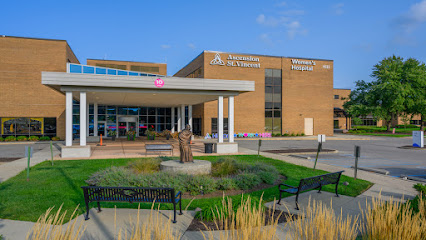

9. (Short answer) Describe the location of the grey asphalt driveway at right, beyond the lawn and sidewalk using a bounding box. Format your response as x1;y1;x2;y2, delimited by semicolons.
238;135;426;179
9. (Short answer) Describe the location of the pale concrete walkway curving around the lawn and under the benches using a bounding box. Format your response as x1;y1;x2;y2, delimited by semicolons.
0;144;416;240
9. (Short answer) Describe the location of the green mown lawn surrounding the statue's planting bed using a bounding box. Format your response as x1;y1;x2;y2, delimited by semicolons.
0;155;372;221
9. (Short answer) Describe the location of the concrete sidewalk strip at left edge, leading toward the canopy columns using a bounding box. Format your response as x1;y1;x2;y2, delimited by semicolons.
0;144;62;183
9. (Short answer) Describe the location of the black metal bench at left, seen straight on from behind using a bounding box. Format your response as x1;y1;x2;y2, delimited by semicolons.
81;186;182;223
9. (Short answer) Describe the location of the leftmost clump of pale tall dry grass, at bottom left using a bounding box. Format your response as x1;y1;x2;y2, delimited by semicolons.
26;205;86;240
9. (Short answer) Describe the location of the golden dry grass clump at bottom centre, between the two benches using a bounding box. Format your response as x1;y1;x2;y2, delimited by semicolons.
202;196;279;240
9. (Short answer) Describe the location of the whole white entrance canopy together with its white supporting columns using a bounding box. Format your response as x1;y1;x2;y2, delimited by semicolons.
42;63;255;154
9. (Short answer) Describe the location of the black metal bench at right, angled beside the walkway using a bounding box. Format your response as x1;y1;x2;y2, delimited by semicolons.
277;171;344;210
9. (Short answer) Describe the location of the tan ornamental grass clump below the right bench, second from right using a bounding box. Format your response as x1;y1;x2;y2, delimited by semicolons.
286;200;358;240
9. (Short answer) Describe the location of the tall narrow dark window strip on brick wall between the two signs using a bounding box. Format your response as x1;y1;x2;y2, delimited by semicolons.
265;69;282;134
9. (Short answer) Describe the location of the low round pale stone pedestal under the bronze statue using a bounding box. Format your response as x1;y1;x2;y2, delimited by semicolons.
160;160;212;175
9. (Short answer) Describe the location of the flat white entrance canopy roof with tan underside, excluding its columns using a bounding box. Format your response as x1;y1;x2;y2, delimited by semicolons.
42;67;254;107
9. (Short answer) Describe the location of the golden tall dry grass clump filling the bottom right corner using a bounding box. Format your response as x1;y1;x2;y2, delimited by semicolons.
361;195;426;240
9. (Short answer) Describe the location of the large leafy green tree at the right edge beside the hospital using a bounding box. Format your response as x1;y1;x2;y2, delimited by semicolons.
343;56;426;131
